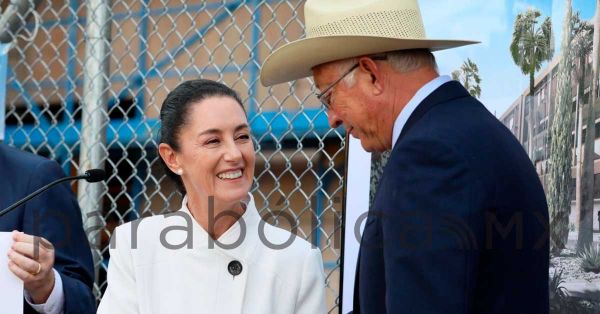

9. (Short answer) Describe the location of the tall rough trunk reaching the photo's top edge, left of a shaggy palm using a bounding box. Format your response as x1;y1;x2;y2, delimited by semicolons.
547;0;573;254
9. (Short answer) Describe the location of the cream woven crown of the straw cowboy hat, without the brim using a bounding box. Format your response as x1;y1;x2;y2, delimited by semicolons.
304;0;426;39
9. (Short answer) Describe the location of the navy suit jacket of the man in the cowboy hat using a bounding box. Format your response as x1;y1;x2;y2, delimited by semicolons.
354;81;549;314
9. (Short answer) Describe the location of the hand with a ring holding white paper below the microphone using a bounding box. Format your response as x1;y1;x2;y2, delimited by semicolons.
8;231;54;304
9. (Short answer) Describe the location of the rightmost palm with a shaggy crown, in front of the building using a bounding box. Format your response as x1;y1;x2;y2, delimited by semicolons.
571;12;596;251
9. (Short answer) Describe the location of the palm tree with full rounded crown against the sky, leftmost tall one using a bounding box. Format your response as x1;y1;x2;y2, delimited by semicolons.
510;8;554;157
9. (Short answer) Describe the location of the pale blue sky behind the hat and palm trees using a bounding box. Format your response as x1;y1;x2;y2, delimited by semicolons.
419;0;596;117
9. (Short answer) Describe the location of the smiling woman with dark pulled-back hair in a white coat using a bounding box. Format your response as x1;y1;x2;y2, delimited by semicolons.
98;80;325;314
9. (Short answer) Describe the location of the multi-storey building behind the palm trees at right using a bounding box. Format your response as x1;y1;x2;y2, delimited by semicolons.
500;39;600;240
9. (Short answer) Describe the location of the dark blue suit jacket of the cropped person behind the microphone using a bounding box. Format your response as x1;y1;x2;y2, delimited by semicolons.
0;144;96;313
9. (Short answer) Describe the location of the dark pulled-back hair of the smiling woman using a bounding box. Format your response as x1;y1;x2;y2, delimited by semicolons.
159;79;246;194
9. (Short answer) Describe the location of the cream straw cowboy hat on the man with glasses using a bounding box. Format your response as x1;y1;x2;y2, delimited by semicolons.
260;0;477;86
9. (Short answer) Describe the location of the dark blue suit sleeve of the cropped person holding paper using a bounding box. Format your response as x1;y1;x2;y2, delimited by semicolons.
23;160;96;313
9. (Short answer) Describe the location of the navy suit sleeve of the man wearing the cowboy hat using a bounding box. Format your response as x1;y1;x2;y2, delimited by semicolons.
381;137;483;314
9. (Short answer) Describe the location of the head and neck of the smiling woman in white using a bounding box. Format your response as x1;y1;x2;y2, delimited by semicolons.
159;80;256;238
